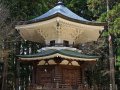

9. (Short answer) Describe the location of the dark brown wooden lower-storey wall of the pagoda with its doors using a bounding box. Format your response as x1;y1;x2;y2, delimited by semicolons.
36;65;82;89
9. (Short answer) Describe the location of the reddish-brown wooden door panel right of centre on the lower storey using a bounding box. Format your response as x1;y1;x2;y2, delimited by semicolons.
63;67;81;87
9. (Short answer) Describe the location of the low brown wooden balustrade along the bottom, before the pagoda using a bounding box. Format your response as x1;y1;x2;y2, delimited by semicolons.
27;84;109;90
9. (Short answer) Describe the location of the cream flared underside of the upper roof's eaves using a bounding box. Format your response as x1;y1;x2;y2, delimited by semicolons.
16;17;104;44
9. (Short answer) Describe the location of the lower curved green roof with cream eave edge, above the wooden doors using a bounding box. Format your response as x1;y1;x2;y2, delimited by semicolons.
18;48;99;61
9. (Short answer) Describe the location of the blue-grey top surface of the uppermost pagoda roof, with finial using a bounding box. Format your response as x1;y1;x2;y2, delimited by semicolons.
29;2;89;22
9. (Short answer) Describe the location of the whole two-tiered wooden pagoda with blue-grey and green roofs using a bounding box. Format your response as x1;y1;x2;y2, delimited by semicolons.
15;2;104;90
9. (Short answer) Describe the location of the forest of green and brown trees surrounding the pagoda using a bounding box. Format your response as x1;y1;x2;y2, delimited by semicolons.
0;0;120;90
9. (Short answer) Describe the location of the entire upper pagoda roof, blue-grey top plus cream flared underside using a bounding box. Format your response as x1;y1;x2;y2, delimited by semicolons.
15;2;105;45
